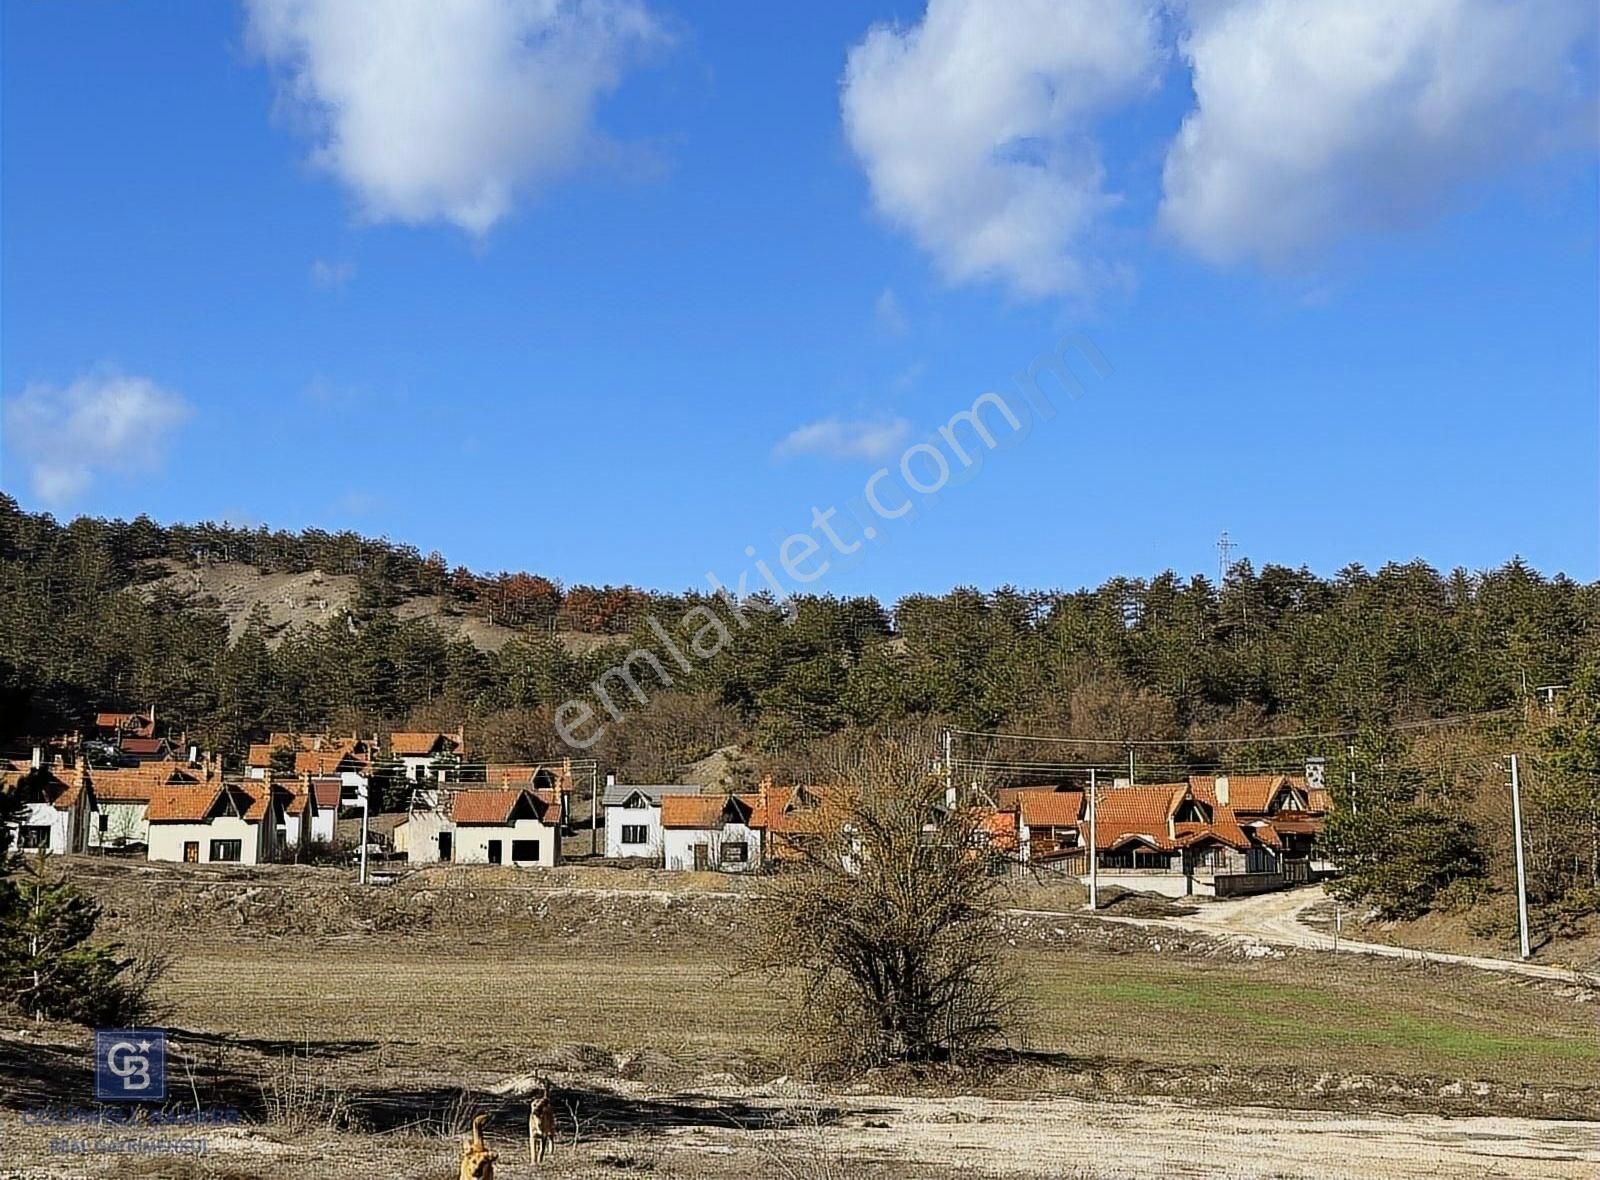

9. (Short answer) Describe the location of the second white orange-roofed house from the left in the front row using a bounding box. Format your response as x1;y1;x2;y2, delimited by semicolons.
147;780;290;865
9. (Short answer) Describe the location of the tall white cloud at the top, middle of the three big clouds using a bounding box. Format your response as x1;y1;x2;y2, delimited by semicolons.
840;0;1162;296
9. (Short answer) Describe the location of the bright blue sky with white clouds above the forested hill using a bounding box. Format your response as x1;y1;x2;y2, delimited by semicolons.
0;0;1600;598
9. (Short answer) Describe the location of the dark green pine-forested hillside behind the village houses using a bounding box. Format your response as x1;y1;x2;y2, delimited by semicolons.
0;497;1600;757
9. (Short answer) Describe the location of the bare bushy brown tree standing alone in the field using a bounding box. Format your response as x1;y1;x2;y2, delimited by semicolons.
752;734;1018;1065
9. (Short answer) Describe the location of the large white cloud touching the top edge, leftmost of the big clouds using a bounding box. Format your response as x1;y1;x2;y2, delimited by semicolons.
246;0;662;235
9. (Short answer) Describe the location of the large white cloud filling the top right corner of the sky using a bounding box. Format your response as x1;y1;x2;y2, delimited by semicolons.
1160;0;1595;264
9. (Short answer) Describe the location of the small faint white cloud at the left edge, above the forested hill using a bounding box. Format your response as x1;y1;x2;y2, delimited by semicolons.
5;374;190;505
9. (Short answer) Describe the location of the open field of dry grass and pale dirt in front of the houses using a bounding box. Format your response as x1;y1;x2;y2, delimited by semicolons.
0;868;1600;1180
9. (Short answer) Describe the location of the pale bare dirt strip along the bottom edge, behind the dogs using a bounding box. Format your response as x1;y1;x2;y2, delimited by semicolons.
0;1089;1600;1180
